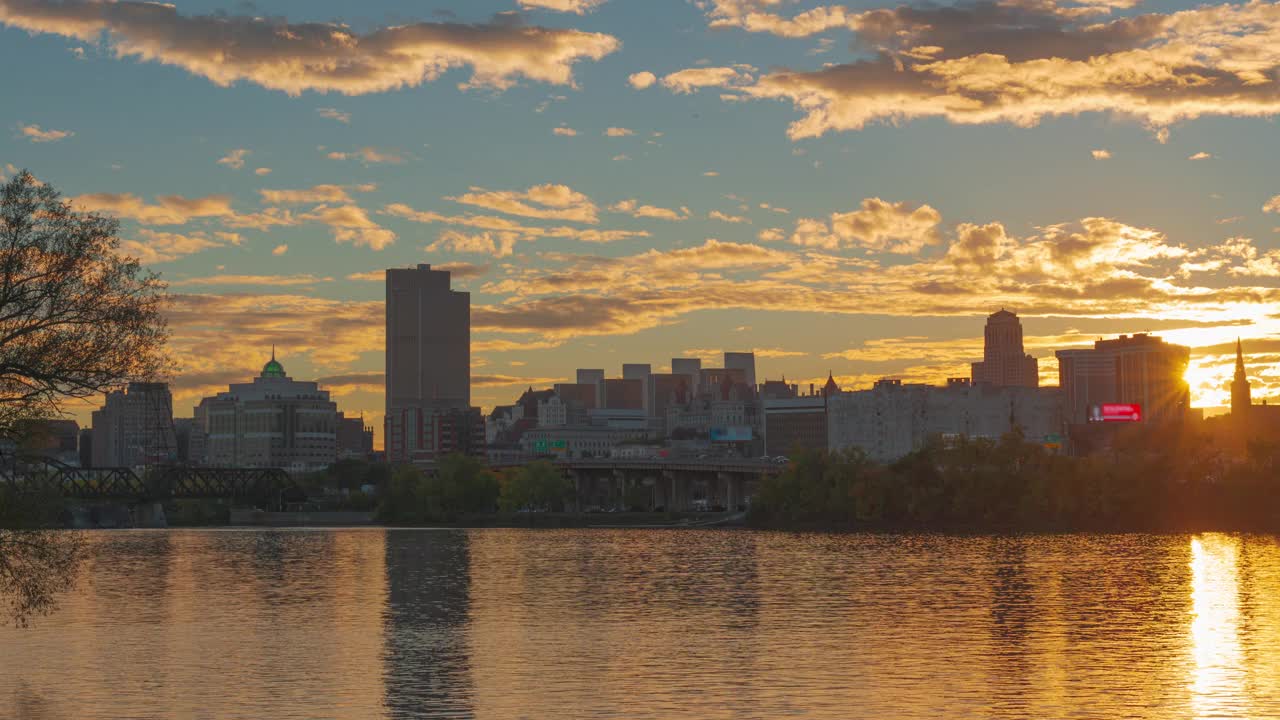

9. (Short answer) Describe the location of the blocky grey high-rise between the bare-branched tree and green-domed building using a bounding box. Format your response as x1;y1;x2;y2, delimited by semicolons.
92;383;178;468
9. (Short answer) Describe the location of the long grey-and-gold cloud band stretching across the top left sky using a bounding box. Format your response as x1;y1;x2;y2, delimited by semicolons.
0;0;620;95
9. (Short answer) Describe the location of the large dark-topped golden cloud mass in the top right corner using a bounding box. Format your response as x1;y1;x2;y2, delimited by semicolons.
713;0;1280;141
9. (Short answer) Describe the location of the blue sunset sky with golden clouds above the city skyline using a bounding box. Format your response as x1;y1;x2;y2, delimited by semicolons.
0;0;1280;436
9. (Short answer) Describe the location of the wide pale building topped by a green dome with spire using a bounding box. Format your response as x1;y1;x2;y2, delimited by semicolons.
192;347;338;473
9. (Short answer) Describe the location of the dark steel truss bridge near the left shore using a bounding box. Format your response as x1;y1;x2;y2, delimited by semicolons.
0;456;306;509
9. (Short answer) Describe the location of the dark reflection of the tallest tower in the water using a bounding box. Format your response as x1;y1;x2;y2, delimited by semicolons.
381;530;474;717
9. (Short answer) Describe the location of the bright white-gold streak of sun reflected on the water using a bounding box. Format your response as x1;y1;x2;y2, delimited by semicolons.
1190;533;1249;717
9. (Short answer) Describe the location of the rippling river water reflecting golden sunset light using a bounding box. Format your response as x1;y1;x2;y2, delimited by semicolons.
0;529;1280;719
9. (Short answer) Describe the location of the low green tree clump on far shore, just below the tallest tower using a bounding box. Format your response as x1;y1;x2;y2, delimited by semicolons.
378;455;573;524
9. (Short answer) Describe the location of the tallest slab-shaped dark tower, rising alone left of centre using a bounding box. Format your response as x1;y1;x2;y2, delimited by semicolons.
384;264;471;462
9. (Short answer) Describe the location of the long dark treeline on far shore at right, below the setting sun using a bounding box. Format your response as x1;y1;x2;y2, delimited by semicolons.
749;427;1280;532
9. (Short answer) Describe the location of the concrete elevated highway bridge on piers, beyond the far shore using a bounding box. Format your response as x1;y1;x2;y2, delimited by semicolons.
489;457;786;512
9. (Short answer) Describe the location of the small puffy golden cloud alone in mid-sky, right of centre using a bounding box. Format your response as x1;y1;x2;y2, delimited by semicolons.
791;197;942;254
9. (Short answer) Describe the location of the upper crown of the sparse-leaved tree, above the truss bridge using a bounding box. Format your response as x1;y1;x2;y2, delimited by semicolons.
0;170;169;434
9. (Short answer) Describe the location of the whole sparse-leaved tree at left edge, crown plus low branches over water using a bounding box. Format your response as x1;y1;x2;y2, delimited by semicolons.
0;170;168;624
